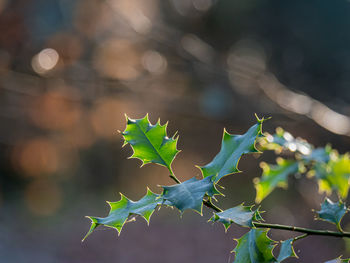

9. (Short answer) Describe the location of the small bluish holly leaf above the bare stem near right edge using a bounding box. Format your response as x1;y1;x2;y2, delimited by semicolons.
316;198;347;227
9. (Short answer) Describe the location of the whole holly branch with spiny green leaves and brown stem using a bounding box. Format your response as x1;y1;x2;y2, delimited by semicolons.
84;115;350;263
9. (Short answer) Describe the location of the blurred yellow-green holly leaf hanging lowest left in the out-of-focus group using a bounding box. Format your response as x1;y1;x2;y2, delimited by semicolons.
254;158;299;203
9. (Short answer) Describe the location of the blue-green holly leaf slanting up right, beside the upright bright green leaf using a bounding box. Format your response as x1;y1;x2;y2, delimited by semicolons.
199;118;264;182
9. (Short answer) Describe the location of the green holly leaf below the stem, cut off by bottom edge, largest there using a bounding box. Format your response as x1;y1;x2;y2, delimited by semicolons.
233;228;276;263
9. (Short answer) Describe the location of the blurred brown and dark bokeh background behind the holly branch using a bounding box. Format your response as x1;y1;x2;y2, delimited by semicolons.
0;0;350;263
